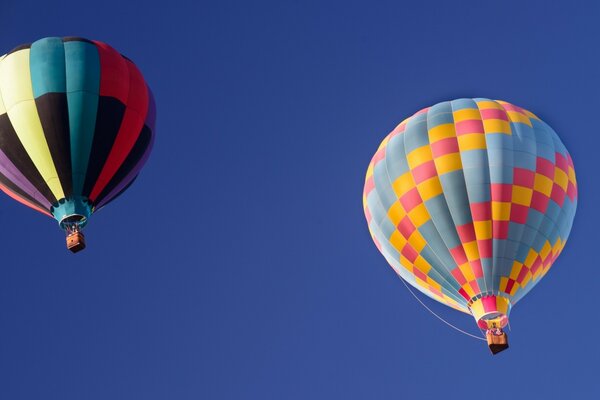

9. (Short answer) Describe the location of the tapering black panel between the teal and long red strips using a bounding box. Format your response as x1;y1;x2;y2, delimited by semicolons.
82;96;125;197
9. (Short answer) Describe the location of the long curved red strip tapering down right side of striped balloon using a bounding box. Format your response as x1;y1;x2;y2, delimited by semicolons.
90;61;149;201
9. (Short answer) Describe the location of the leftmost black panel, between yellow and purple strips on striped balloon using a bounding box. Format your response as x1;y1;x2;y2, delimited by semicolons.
0;114;58;203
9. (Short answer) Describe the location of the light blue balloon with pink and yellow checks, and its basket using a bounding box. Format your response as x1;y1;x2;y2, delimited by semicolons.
363;98;577;354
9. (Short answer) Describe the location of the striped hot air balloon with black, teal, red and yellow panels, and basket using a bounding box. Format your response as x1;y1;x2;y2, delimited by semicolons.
0;37;155;252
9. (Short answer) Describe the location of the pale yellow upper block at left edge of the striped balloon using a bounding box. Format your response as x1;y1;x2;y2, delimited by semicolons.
0;49;33;110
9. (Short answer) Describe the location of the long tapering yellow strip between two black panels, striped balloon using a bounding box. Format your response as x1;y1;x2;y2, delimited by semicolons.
2;101;65;199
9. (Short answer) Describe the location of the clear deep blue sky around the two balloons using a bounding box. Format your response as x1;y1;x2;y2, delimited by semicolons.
0;0;600;400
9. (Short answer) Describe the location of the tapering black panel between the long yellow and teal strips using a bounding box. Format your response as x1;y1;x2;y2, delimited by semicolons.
35;93;73;197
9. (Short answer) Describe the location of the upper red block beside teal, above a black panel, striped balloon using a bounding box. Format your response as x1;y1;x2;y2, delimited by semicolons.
94;42;129;104
